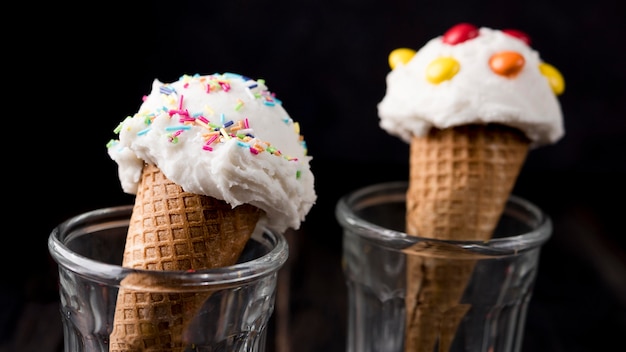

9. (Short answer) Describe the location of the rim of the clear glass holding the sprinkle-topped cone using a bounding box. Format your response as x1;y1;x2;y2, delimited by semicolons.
48;205;289;287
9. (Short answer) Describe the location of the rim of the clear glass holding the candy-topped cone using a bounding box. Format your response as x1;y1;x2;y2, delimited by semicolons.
335;181;552;256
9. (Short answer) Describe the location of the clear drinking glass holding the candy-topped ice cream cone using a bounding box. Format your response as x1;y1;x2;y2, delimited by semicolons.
336;182;552;352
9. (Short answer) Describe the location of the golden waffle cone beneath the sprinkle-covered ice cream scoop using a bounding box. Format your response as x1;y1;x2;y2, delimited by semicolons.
109;165;261;352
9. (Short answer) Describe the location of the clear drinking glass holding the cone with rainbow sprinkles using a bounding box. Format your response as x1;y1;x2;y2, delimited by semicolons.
48;206;289;352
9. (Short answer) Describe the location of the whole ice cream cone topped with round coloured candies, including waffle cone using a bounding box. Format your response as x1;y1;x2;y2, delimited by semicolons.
378;23;564;351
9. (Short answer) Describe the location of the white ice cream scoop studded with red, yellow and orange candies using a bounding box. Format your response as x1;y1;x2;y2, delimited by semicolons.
378;23;564;147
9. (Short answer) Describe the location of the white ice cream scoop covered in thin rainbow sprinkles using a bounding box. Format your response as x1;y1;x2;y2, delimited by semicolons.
107;73;316;232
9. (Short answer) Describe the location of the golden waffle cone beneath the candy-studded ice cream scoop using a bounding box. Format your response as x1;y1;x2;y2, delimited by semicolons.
405;124;529;352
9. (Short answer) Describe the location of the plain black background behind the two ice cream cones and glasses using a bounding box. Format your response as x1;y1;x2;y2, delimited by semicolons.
0;0;626;352
